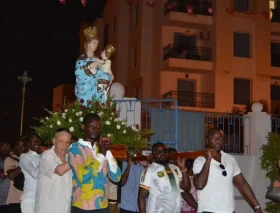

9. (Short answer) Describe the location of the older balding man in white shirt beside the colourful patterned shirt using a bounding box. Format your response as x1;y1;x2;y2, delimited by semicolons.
35;128;72;213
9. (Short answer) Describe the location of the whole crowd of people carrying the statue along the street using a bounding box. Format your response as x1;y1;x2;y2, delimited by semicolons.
0;113;262;213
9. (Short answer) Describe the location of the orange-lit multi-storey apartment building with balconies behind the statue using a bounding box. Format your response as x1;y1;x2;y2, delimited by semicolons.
88;0;280;112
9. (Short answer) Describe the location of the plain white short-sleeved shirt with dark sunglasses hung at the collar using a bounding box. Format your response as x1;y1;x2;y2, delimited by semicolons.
193;152;241;213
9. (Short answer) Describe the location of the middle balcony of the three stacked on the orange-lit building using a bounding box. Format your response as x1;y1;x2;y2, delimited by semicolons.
162;44;213;73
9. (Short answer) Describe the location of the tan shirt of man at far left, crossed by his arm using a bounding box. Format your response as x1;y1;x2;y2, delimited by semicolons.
4;153;22;204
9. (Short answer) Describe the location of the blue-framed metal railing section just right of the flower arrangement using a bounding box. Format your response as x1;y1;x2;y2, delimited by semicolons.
112;99;178;149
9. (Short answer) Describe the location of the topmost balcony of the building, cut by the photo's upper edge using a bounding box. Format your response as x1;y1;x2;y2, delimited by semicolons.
163;0;213;27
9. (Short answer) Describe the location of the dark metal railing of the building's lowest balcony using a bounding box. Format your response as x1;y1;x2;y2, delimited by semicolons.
162;90;215;109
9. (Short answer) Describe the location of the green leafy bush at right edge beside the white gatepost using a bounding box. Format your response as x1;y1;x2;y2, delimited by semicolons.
261;133;280;213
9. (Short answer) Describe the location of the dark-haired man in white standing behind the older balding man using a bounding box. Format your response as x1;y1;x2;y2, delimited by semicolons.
19;133;41;213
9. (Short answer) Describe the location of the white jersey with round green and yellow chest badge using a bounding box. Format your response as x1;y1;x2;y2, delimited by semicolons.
139;163;182;213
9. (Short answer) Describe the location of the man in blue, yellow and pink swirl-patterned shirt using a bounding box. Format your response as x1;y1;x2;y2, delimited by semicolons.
68;113;121;213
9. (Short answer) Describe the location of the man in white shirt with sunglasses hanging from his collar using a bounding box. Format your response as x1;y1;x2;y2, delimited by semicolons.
193;128;262;213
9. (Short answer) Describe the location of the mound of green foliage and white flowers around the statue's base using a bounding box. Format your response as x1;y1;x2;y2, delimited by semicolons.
32;98;152;155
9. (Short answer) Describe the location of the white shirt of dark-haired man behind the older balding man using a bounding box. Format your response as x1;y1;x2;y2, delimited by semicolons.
19;150;40;199
